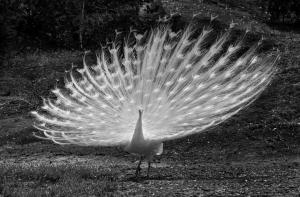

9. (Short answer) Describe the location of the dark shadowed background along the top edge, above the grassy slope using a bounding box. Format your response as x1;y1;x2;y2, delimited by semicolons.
0;0;300;52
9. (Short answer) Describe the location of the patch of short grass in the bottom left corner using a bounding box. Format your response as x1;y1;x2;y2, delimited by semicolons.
0;164;118;196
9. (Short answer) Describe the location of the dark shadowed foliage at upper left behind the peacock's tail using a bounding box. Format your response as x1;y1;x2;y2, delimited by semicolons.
0;0;162;49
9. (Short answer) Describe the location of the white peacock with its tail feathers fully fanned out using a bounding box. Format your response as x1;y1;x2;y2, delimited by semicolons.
31;22;278;176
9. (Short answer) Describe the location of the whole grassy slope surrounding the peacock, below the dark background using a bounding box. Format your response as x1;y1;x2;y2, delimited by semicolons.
0;0;300;196
